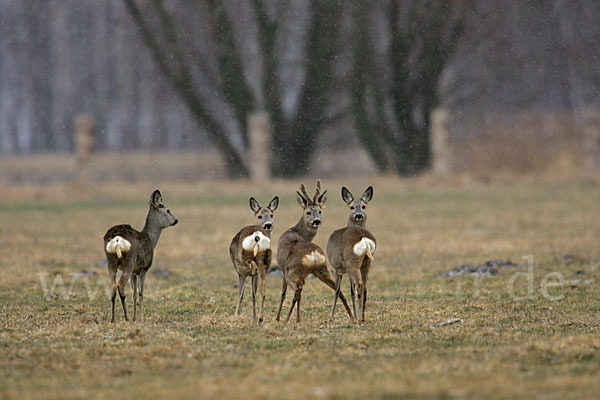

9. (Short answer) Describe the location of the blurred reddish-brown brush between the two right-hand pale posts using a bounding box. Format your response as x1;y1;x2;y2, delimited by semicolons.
452;112;584;174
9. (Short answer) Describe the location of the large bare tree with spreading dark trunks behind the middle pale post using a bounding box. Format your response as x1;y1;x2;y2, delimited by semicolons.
124;0;340;176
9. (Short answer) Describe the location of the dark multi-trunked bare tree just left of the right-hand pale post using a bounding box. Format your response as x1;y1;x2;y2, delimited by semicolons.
351;0;471;175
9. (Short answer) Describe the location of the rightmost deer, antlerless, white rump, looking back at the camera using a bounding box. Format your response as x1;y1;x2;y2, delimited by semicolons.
327;186;377;322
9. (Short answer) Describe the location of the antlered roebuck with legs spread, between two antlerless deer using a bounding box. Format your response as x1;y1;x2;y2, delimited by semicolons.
276;181;353;322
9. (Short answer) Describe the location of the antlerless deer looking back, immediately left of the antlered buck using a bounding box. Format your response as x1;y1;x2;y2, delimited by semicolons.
229;196;279;323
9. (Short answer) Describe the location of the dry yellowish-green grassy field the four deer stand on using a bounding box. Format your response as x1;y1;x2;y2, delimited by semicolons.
0;173;600;399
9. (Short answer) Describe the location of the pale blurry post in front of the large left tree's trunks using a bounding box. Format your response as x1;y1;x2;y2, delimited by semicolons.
247;112;271;181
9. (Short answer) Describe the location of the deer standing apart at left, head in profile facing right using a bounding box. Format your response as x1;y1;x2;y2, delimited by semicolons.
104;190;178;322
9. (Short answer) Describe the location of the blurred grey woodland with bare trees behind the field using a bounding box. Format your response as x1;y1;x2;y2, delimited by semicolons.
0;0;600;176
